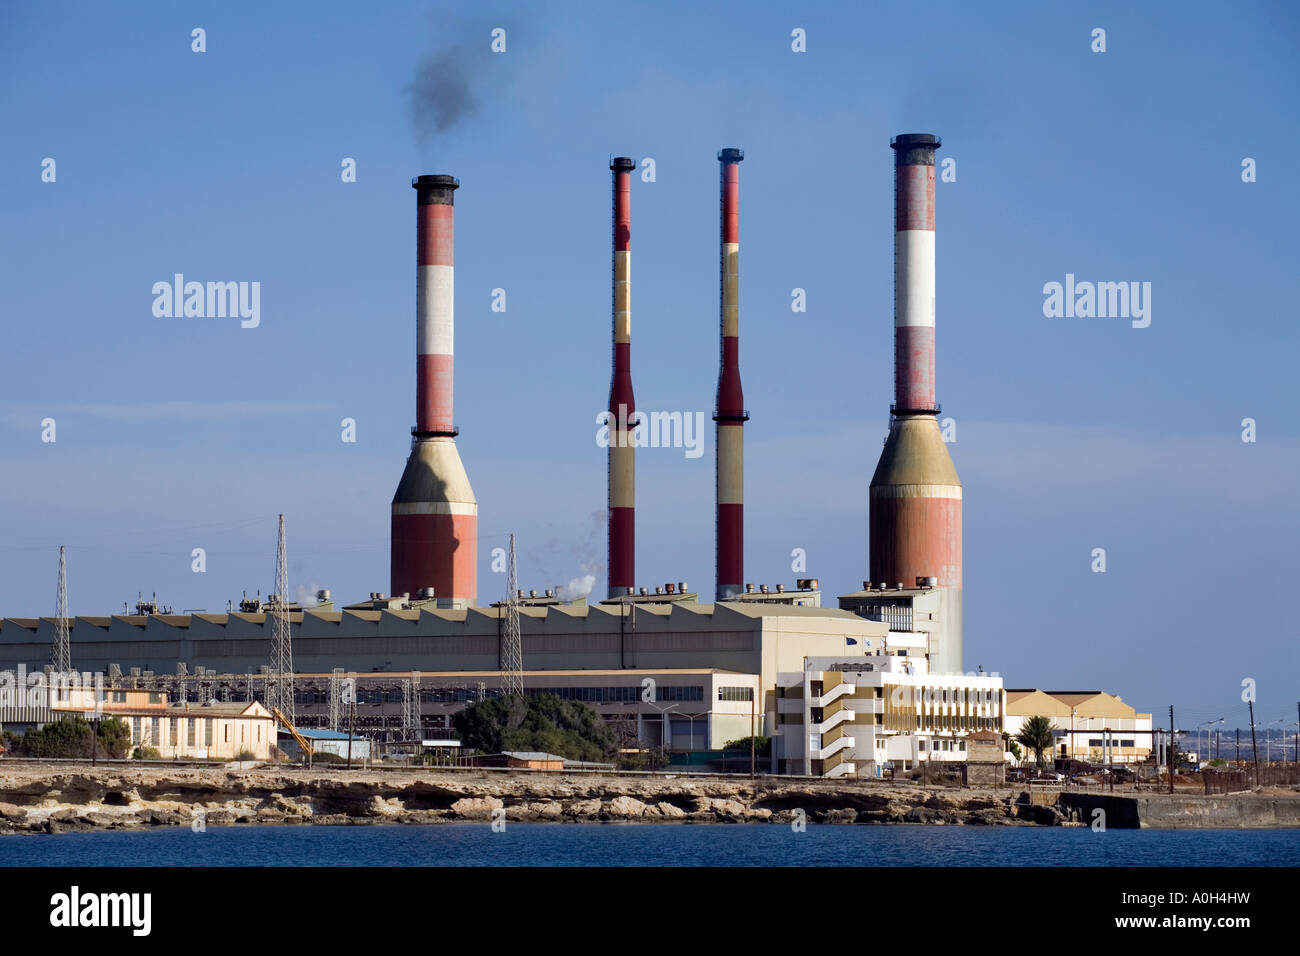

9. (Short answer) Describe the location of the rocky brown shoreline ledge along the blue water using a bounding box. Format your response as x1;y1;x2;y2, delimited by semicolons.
0;763;1300;835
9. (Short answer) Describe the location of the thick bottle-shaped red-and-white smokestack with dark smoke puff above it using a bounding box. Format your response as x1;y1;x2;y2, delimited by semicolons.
390;176;478;607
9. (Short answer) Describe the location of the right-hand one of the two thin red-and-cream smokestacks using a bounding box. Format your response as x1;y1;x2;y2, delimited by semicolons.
714;148;749;601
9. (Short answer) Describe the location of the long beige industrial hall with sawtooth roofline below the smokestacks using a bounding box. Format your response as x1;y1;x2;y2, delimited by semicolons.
0;600;888;749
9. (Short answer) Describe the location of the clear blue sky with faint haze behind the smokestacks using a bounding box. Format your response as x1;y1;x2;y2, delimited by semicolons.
0;3;1300;726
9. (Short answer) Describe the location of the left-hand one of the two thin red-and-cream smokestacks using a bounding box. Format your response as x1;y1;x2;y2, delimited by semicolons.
608;156;637;597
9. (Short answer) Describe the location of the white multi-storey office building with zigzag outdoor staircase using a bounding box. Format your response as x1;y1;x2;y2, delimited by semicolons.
771;650;1005;777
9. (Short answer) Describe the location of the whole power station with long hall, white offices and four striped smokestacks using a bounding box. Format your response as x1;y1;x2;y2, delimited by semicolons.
0;134;1149;775
